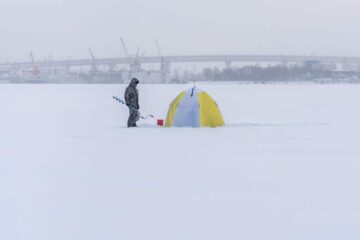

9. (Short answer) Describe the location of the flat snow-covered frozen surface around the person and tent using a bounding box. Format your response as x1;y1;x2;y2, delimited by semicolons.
0;84;360;240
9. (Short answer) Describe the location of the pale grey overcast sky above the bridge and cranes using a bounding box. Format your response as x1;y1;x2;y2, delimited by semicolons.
0;0;360;62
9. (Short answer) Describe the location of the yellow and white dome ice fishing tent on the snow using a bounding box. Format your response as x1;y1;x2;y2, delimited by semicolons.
165;87;224;127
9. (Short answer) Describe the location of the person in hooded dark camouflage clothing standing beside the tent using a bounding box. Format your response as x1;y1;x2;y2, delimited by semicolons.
125;78;140;127
